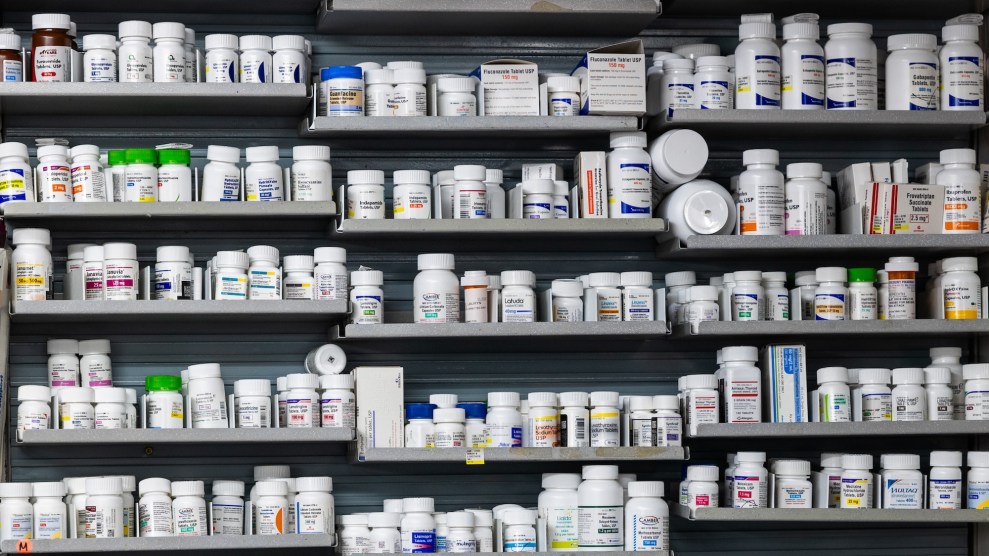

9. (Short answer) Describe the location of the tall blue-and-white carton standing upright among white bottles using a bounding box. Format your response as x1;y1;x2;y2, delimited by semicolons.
762;345;810;423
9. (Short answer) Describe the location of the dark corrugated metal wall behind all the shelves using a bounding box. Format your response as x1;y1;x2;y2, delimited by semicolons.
2;0;977;556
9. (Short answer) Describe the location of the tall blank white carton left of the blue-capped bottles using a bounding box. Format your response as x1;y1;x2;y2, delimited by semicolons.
353;367;405;461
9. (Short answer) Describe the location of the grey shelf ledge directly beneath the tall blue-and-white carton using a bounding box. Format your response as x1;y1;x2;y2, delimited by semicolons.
687;421;989;438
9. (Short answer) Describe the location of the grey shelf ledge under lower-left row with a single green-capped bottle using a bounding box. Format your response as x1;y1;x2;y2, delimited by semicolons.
19;427;354;446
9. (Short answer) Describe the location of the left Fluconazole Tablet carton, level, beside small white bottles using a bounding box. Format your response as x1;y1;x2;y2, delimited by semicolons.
470;59;539;116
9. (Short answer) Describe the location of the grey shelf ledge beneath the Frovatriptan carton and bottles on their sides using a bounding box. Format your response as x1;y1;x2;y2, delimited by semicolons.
656;234;989;262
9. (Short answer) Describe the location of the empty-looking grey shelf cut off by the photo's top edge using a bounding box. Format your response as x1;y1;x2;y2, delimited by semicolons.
316;0;662;37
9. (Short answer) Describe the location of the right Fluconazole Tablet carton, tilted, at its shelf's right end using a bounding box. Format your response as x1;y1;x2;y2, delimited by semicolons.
570;40;646;116
